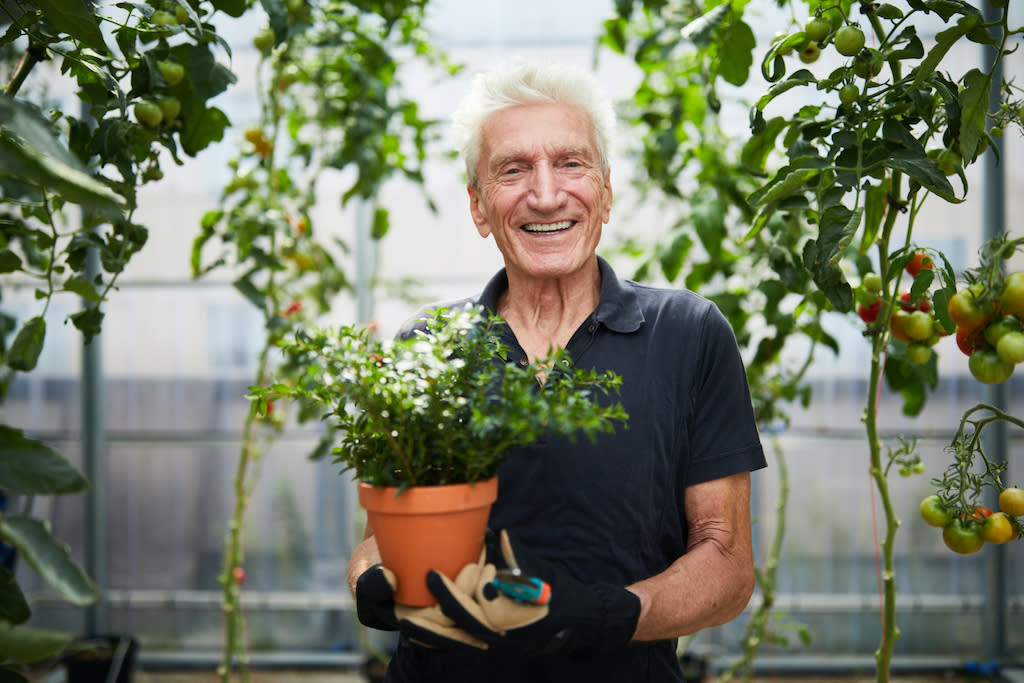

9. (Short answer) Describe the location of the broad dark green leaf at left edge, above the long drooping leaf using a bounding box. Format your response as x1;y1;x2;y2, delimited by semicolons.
0;425;89;496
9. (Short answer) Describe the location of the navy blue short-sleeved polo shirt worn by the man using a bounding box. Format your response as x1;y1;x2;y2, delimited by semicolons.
387;258;766;683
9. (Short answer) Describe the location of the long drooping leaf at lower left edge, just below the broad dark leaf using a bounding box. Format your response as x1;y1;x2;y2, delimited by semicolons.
0;515;99;607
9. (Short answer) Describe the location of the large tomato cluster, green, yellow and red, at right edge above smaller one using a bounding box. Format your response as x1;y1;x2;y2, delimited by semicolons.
948;271;1024;384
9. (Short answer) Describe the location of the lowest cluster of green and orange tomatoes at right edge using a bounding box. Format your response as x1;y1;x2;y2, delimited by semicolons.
921;486;1024;555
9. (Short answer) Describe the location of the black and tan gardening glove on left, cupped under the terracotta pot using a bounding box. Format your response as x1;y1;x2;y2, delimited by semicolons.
355;551;486;650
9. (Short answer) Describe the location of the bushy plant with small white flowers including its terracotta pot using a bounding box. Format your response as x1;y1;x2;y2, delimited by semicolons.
251;307;627;605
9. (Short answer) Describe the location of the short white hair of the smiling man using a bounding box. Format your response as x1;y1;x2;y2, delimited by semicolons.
452;58;615;187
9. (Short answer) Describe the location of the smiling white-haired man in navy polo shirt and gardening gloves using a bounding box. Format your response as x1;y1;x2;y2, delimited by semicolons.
349;60;765;683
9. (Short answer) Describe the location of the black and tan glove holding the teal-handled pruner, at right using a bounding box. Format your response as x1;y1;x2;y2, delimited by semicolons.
427;530;640;655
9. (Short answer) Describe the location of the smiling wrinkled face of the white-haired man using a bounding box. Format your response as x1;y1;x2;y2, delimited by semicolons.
470;103;611;280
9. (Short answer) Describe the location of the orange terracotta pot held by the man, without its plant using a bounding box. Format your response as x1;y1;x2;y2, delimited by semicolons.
358;476;498;607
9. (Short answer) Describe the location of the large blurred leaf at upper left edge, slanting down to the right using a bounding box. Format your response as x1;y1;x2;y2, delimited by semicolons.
0;94;124;214
